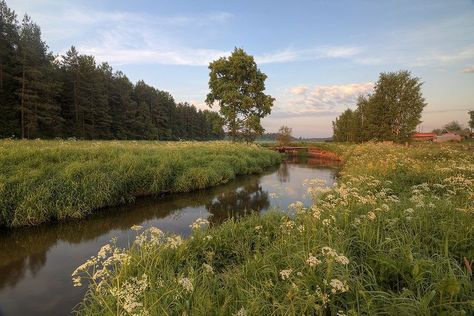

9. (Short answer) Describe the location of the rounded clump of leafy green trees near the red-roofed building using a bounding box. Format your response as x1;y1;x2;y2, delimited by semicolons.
332;70;426;142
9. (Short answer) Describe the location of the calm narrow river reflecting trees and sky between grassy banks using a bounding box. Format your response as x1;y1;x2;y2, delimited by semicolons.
0;160;337;316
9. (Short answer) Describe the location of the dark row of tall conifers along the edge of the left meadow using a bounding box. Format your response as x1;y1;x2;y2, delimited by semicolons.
0;0;224;140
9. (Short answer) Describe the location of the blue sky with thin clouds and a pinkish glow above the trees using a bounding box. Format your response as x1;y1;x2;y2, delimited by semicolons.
7;0;474;137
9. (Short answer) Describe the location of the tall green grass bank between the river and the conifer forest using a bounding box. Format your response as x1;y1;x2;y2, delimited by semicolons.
0;140;280;226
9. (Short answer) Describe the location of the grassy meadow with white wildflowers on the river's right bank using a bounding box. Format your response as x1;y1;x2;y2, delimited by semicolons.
73;144;474;316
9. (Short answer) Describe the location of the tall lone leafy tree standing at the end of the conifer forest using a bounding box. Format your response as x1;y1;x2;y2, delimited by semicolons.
206;48;274;141
